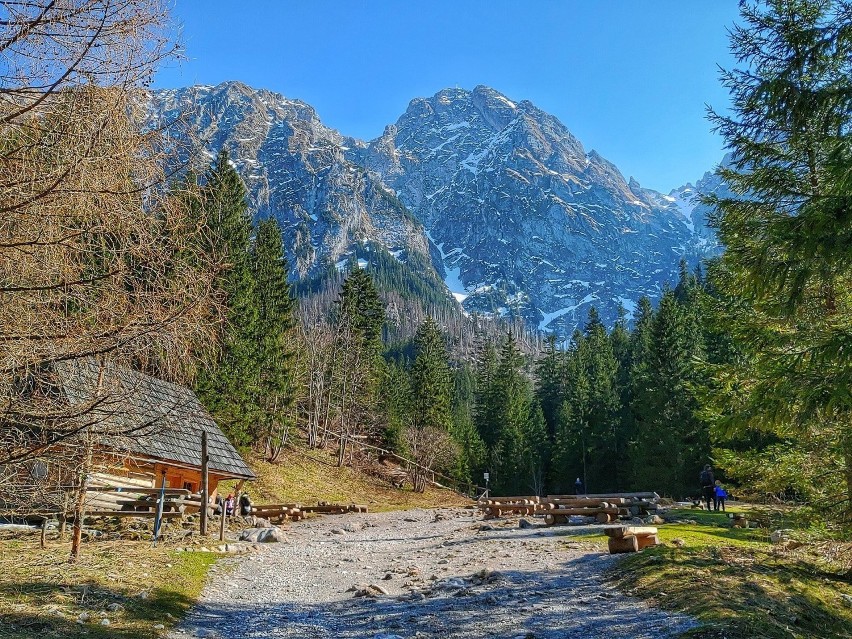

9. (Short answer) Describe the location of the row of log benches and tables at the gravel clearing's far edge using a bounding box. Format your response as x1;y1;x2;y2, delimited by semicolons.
479;492;660;526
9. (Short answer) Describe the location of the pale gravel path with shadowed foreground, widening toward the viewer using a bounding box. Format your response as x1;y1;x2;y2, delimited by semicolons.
169;509;695;639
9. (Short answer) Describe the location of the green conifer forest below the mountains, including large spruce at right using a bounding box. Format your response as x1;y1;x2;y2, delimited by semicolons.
188;2;852;515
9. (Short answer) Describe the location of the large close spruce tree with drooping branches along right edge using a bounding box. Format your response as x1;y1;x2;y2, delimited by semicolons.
707;0;852;518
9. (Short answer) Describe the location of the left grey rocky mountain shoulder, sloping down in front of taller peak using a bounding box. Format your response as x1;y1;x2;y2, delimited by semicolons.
151;82;437;277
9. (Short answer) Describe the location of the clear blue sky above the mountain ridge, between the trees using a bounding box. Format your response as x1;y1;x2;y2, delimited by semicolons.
156;0;737;191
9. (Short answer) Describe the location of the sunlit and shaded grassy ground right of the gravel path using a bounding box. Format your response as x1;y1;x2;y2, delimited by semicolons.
564;511;852;639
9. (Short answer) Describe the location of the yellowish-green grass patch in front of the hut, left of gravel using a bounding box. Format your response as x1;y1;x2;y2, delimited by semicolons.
0;534;217;639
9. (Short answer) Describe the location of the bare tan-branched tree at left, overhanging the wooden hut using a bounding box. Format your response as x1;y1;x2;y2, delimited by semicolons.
0;0;218;556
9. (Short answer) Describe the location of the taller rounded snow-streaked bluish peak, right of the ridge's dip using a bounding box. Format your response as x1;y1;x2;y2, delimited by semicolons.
348;87;712;332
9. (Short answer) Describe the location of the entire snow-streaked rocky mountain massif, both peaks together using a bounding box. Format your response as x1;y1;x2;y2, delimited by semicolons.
151;82;716;335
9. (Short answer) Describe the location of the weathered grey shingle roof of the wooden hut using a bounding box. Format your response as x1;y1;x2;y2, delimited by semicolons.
55;358;255;479
